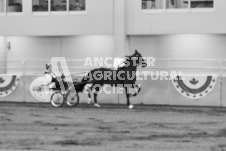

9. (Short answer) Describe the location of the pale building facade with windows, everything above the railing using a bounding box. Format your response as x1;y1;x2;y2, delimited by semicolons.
0;0;226;63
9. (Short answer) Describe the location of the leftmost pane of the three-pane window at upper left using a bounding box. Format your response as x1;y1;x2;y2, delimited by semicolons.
32;0;49;12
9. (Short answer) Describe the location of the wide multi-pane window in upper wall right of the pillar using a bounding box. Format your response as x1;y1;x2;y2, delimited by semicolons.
141;0;214;12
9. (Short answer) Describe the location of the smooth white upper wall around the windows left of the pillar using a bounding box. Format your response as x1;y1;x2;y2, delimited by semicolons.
0;0;113;36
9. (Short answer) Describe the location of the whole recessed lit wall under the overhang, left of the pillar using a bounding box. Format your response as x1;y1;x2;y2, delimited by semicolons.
7;35;114;74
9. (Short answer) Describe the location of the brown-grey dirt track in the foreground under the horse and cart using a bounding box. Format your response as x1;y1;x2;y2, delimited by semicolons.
0;103;226;151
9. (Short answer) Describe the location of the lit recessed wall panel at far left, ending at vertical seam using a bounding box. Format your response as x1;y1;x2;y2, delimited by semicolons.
7;36;60;61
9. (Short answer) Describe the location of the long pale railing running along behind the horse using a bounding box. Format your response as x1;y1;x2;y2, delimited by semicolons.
0;59;223;77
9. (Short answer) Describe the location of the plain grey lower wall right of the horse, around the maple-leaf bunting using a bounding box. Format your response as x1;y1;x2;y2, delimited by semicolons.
119;75;222;106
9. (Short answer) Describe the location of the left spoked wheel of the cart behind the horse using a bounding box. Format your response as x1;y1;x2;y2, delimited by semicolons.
50;92;64;107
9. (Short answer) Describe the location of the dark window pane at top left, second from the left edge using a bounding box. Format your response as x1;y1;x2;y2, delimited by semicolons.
7;0;23;13
